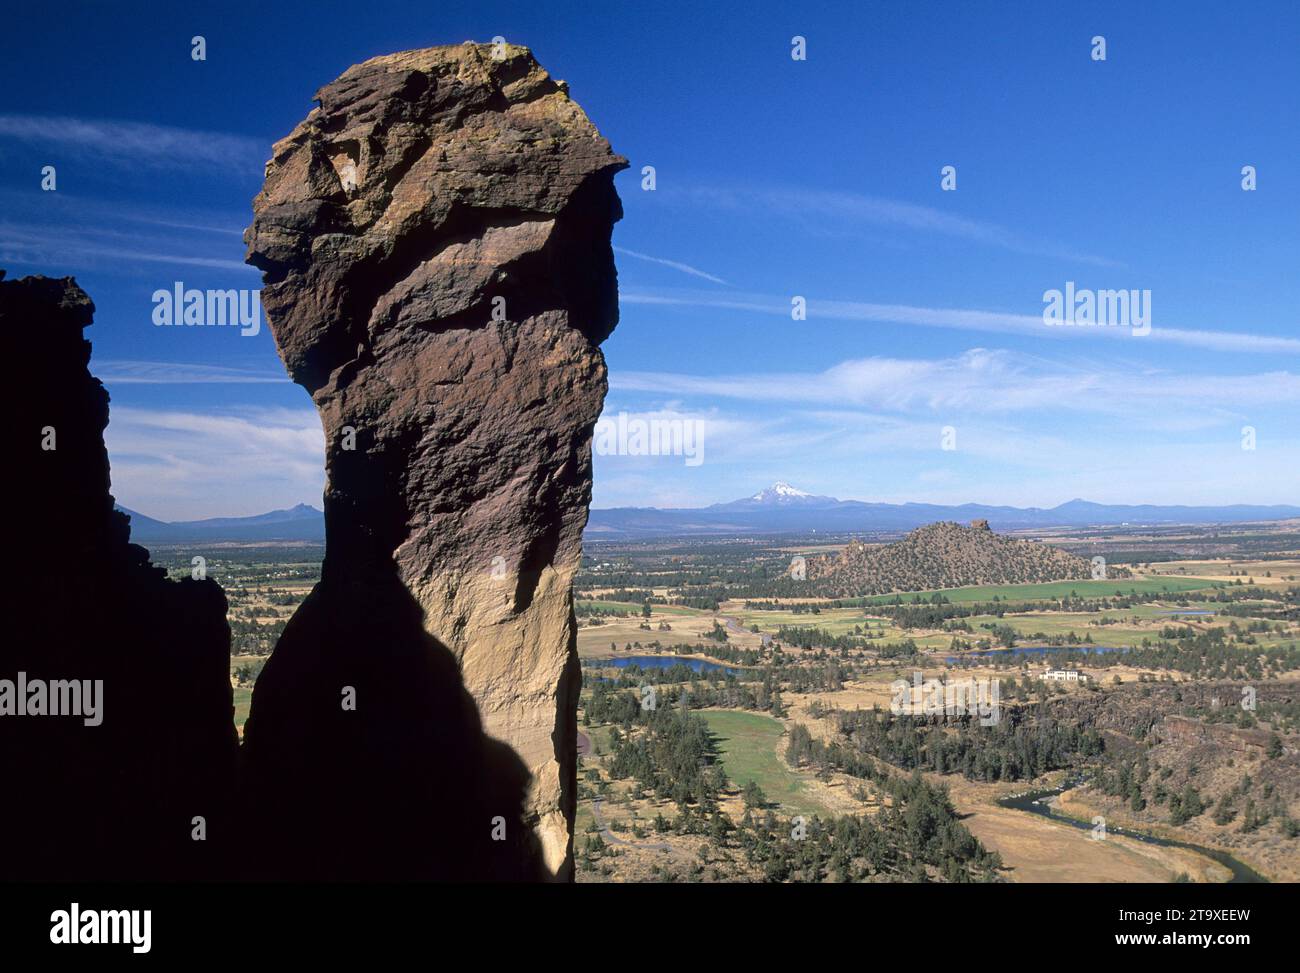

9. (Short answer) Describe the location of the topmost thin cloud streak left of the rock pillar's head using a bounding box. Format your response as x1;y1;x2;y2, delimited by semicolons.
0;114;270;172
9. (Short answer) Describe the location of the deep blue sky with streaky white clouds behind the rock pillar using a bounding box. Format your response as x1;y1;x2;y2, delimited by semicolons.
0;0;1300;519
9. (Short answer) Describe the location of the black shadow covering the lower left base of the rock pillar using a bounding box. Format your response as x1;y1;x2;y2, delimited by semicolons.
243;568;547;881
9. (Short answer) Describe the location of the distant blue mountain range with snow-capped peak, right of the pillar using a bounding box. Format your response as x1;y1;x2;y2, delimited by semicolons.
586;483;1300;540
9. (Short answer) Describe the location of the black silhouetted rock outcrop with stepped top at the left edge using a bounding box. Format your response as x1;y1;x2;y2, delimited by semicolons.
0;272;238;879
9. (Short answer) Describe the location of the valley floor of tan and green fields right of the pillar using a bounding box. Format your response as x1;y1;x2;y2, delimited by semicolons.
575;546;1300;883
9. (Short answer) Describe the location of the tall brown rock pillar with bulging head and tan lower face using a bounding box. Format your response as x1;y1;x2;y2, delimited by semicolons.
246;43;627;878
